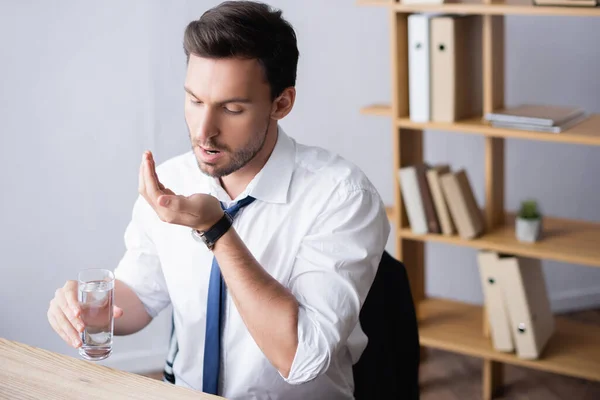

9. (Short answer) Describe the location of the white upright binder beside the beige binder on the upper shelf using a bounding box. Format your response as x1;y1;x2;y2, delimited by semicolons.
408;14;431;122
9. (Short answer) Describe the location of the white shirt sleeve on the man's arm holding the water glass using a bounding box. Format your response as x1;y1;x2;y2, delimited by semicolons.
114;196;170;318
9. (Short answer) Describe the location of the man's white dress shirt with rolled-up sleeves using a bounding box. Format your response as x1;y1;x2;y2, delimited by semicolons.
115;127;390;400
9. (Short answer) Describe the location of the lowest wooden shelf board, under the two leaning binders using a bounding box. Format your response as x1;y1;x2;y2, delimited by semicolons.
419;299;600;381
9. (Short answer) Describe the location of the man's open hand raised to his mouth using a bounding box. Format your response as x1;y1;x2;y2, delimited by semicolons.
138;151;223;231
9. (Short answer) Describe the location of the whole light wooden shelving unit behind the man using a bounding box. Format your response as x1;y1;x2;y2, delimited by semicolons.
358;0;600;400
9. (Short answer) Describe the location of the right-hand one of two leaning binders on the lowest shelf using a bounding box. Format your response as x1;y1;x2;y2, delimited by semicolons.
496;255;555;359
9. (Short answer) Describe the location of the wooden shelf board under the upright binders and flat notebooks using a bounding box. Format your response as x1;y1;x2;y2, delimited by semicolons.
397;114;600;146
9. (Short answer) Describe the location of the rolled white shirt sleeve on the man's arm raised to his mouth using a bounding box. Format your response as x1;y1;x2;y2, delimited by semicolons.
282;189;390;384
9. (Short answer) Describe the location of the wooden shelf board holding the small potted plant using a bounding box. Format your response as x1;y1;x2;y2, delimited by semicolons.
398;214;600;267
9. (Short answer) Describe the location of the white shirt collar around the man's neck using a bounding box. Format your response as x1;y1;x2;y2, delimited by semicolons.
209;125;296;204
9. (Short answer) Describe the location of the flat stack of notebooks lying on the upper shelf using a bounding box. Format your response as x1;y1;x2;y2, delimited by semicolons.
485;104;589;133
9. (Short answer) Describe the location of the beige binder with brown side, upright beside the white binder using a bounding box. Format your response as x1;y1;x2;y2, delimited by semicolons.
430;15;482;122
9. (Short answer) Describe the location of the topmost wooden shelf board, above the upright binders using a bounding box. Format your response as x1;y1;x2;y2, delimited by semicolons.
357;0;600;17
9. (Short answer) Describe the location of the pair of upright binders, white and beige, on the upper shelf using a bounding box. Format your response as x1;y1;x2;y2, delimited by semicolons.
403;13;482;122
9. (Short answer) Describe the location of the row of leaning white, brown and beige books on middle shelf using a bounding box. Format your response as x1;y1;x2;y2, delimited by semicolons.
398;163;484;239
